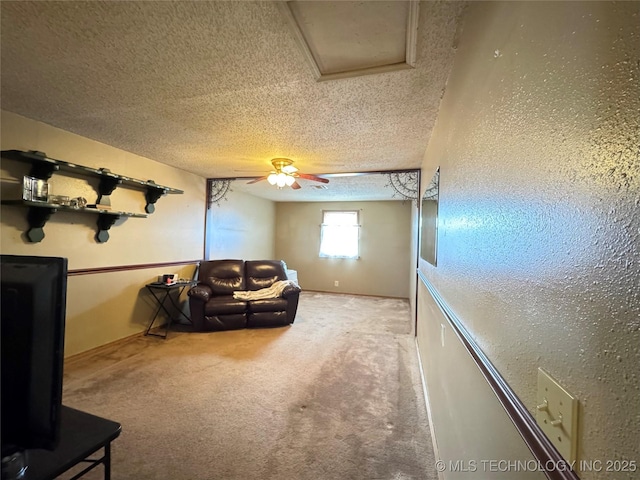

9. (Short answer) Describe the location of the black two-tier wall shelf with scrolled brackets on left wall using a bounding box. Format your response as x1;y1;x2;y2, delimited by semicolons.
0;150;184;243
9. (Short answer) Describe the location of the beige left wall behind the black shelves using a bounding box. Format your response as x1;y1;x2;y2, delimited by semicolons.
0;111;206;356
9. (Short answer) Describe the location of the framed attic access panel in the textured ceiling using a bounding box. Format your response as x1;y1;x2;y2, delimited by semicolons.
278;1;419;81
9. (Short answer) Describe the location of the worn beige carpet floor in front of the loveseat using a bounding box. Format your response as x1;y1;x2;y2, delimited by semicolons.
63;292;437;480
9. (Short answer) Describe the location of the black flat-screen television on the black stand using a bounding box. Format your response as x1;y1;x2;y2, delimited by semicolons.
0;255;67;458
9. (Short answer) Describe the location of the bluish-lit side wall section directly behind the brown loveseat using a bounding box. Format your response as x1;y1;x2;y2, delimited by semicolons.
206;190;276;260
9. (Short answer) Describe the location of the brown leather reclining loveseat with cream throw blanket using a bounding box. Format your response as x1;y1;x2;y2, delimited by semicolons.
188;260;300;331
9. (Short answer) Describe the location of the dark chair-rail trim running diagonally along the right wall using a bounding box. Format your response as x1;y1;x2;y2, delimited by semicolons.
418;270;580;480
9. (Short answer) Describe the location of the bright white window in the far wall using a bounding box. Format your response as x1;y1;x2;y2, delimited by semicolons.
320;210;360;258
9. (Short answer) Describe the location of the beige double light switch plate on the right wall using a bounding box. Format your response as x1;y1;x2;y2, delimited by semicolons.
536;368;578;462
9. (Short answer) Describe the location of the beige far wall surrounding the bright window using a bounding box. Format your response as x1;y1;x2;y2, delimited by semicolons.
276;201;415;298
